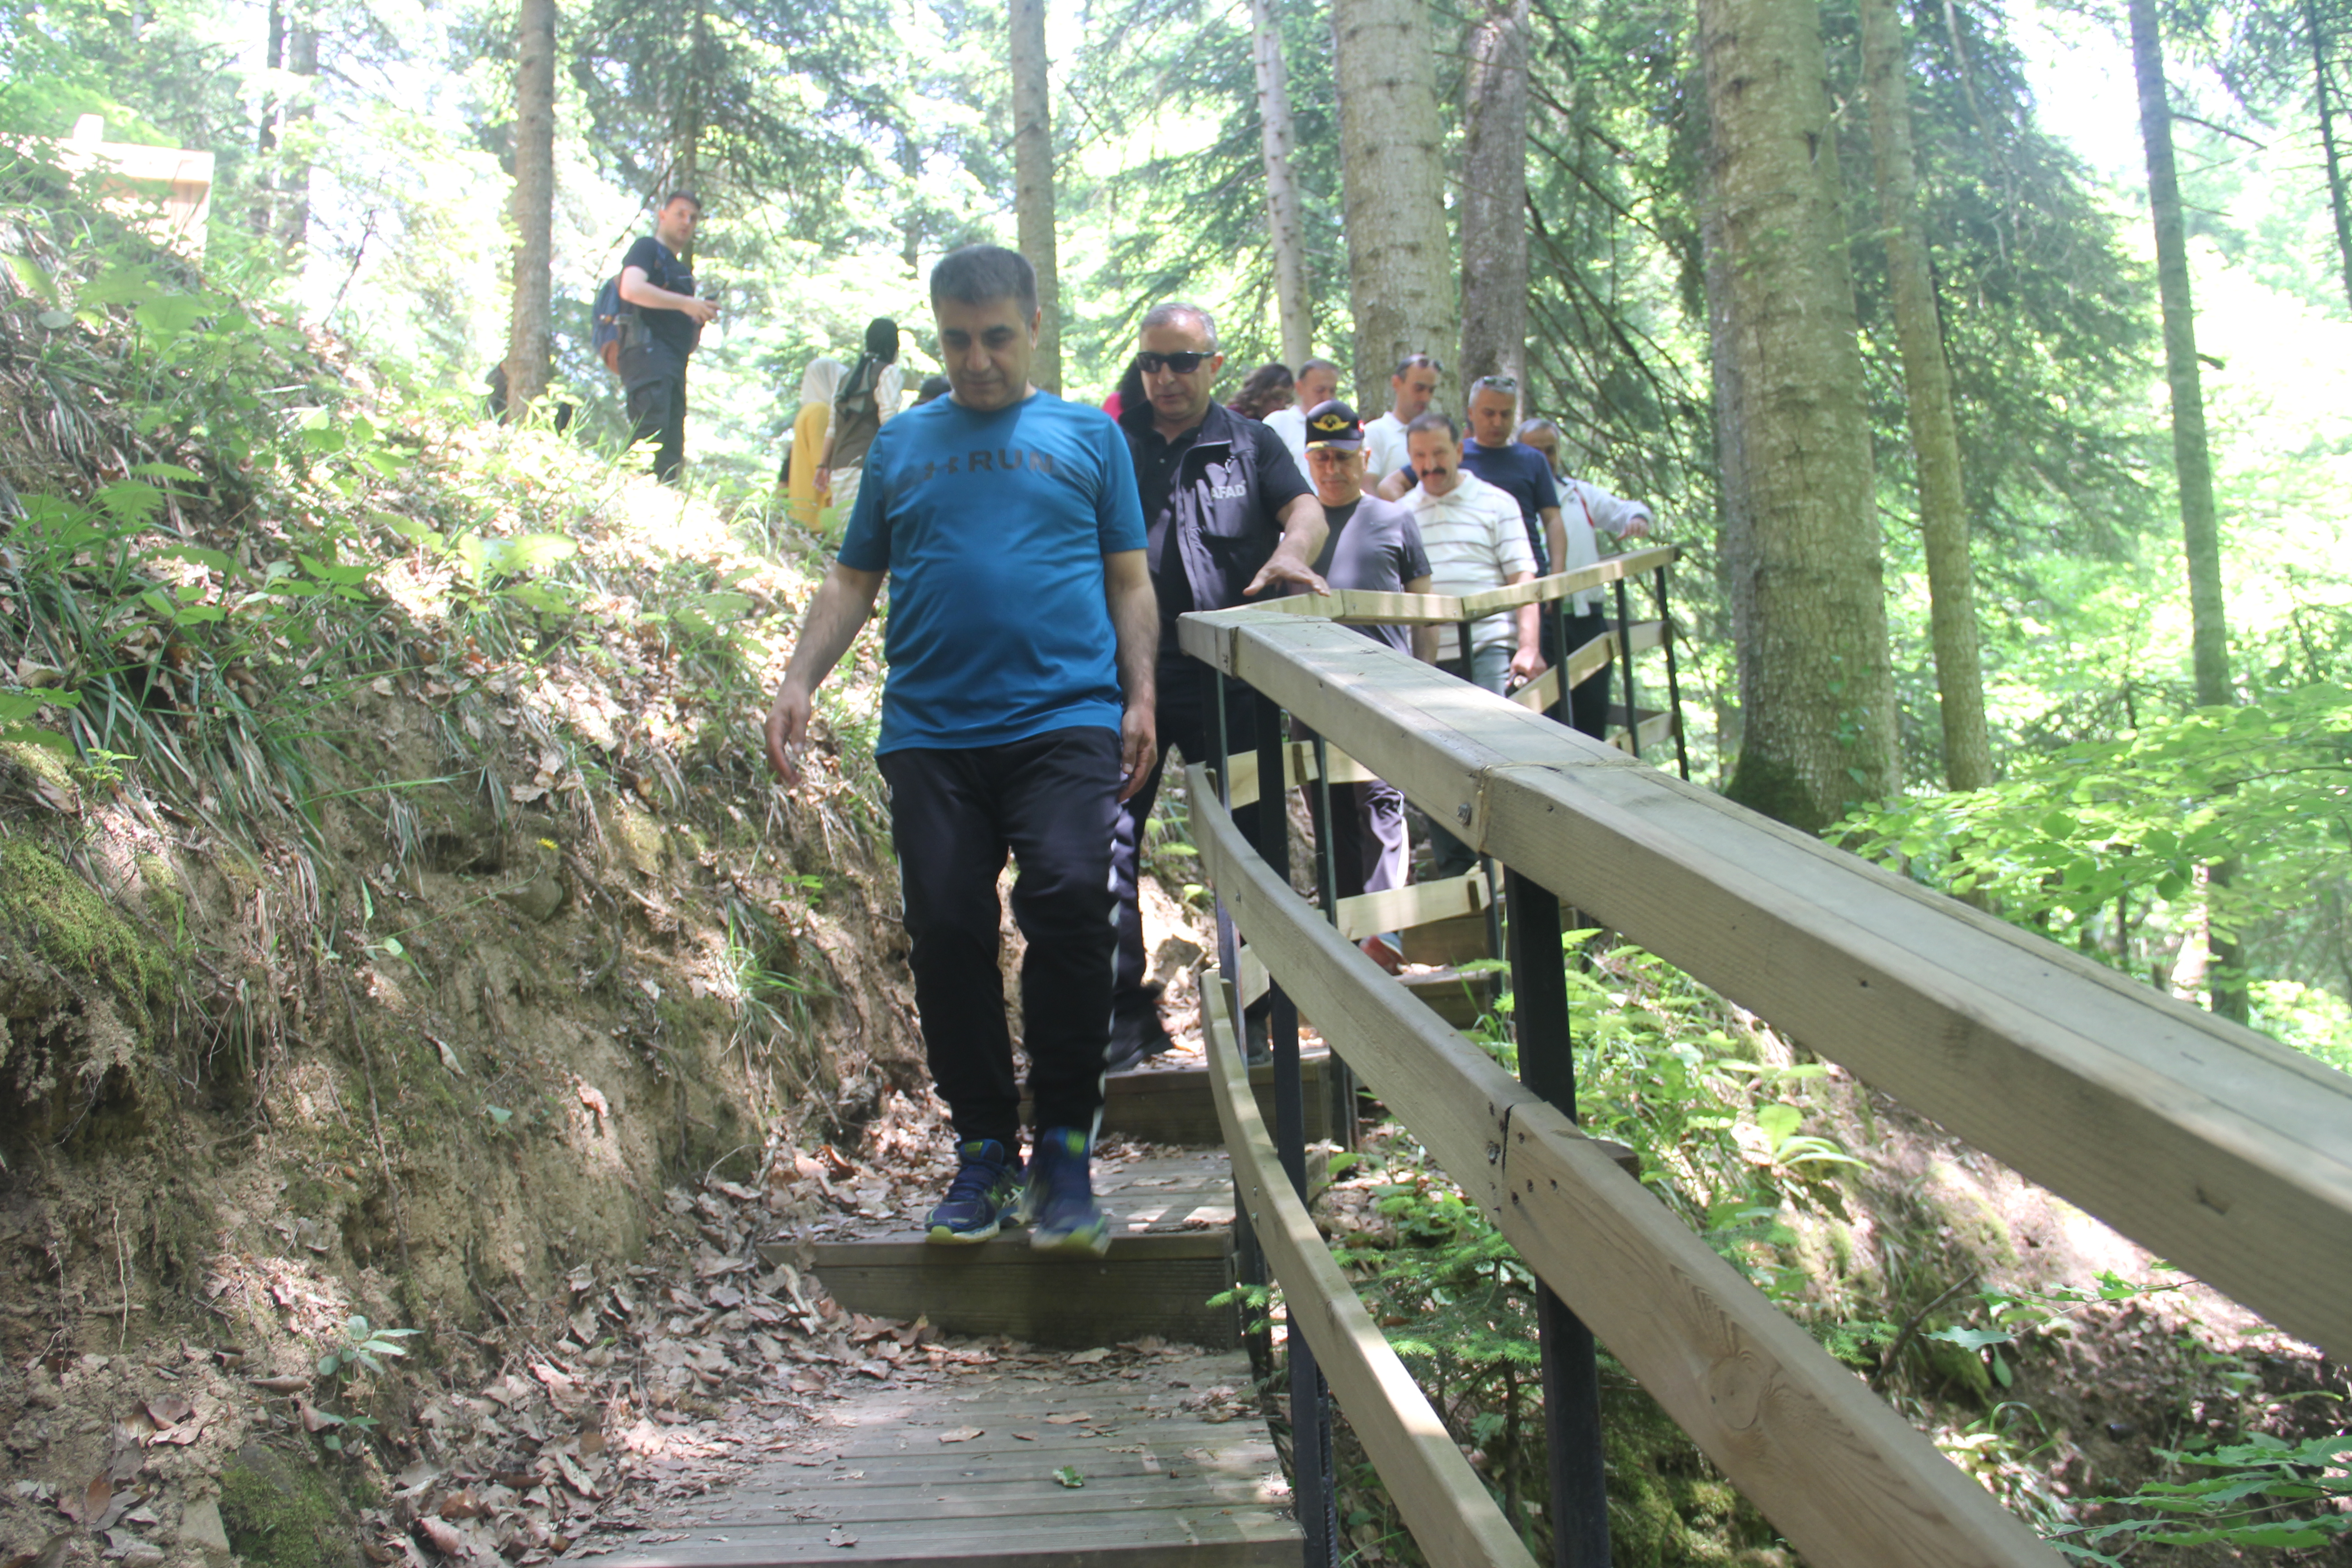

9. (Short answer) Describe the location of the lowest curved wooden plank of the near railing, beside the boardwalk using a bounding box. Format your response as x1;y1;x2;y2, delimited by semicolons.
1202;968;1534;1568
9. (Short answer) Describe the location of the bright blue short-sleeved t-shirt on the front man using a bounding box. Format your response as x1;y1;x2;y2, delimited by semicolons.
840;392;1143;752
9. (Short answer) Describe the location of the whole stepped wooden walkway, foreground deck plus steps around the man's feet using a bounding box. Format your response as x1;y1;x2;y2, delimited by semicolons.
630;1053;1329;1568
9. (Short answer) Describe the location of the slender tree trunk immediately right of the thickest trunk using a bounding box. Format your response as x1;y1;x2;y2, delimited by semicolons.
1861;0;1992;790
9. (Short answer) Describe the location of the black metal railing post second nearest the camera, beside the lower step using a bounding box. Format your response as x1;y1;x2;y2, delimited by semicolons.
1235;696;1338;1568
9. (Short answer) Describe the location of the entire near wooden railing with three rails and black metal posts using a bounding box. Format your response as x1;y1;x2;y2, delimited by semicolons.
1181;602;2352;1568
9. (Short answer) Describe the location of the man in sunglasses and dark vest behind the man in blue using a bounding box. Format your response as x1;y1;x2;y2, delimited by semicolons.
1108;301;1324;1072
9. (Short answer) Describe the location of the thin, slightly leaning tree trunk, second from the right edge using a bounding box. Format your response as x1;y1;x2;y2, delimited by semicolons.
2126;0;2246;1023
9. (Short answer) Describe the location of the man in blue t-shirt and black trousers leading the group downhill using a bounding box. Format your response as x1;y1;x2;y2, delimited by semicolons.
767;245;1160;1253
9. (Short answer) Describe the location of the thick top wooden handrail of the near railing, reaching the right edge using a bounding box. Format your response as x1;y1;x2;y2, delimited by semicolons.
1181;607;2352;1359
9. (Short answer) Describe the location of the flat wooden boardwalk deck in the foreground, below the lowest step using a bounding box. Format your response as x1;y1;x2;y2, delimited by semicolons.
578;1347;1301;1568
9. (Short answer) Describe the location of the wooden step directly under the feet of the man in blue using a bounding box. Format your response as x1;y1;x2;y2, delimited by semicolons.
781;1150;1242;1349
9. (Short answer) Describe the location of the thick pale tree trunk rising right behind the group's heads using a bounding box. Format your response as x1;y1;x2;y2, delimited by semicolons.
1331;0;1460;414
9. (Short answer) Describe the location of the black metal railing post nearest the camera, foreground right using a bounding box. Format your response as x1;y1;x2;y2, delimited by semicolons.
1503;867;1609;1568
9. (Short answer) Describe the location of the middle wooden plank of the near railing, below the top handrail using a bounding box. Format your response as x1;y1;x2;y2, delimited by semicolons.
1192;771;2060;1568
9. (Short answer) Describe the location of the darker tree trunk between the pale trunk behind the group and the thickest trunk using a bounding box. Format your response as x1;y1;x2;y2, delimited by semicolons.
1460;0;1529;388
